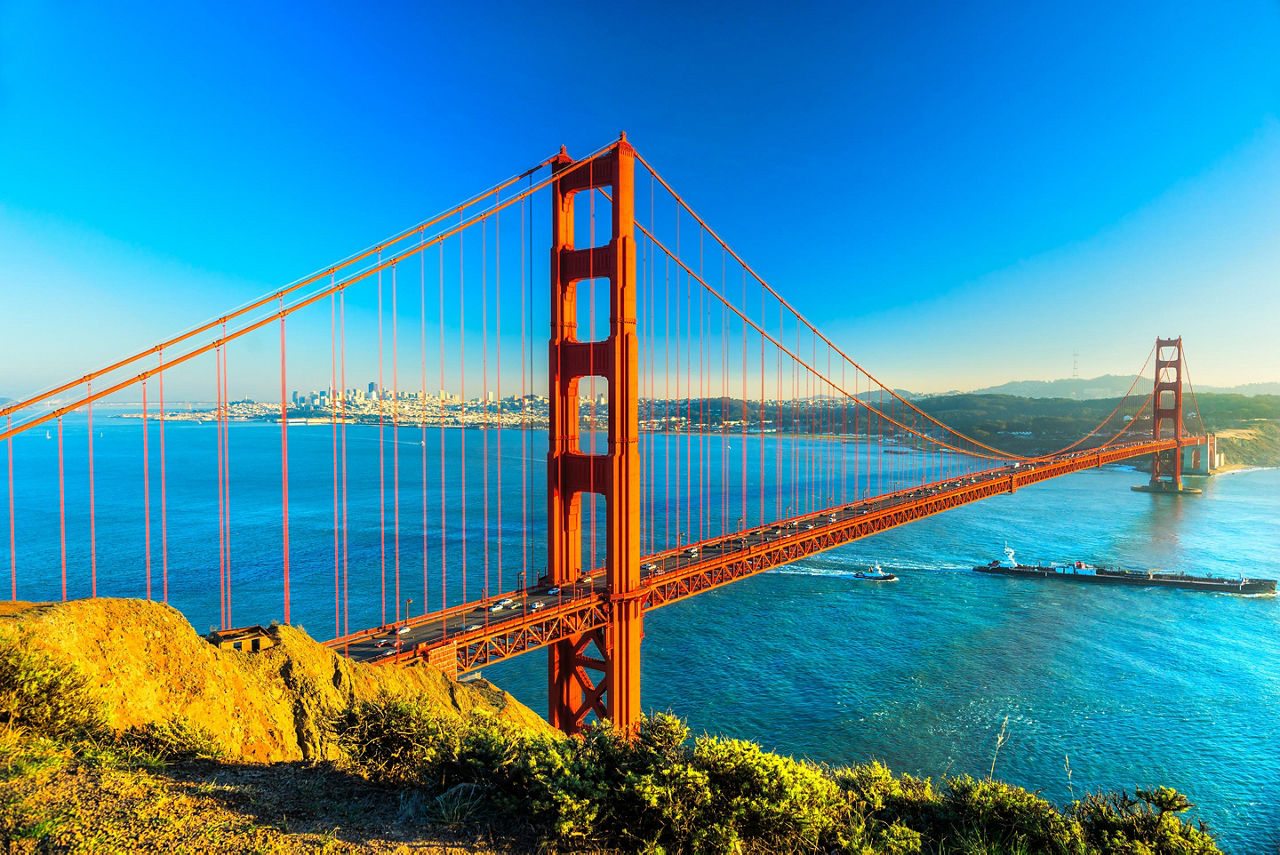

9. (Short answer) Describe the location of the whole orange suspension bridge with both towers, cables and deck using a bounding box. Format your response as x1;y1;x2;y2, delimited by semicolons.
0;136;1204;732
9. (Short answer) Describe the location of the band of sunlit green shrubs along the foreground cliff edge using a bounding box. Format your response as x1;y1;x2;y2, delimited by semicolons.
334;698;1217;855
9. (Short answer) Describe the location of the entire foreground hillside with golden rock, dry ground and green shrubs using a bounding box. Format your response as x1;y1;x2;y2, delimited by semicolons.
0;600;1217;855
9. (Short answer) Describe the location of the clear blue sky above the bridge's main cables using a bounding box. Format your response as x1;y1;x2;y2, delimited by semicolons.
0;0;1280;396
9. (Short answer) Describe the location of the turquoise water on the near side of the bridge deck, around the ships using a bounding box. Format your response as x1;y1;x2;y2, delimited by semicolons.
485;468;1280;852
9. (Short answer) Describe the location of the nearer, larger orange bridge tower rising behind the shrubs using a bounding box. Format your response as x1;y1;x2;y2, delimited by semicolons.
547;134;644;733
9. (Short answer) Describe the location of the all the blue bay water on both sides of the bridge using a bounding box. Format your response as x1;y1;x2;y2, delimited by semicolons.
0;412;1280;852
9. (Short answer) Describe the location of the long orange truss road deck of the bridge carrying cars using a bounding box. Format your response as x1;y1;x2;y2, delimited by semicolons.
326;439;1172;673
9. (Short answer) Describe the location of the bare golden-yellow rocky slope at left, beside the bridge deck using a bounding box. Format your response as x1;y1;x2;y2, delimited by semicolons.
0;598;548;762
